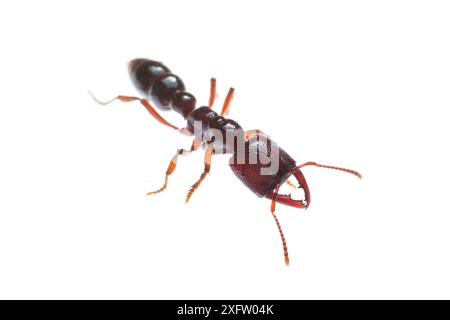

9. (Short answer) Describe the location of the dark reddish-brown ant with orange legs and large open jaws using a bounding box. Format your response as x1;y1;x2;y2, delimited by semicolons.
91;59;362;265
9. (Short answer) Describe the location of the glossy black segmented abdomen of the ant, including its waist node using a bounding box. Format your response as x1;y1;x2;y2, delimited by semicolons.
129;59;196;118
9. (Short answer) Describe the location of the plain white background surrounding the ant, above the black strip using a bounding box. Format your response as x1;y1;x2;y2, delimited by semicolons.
0;0;450;299
